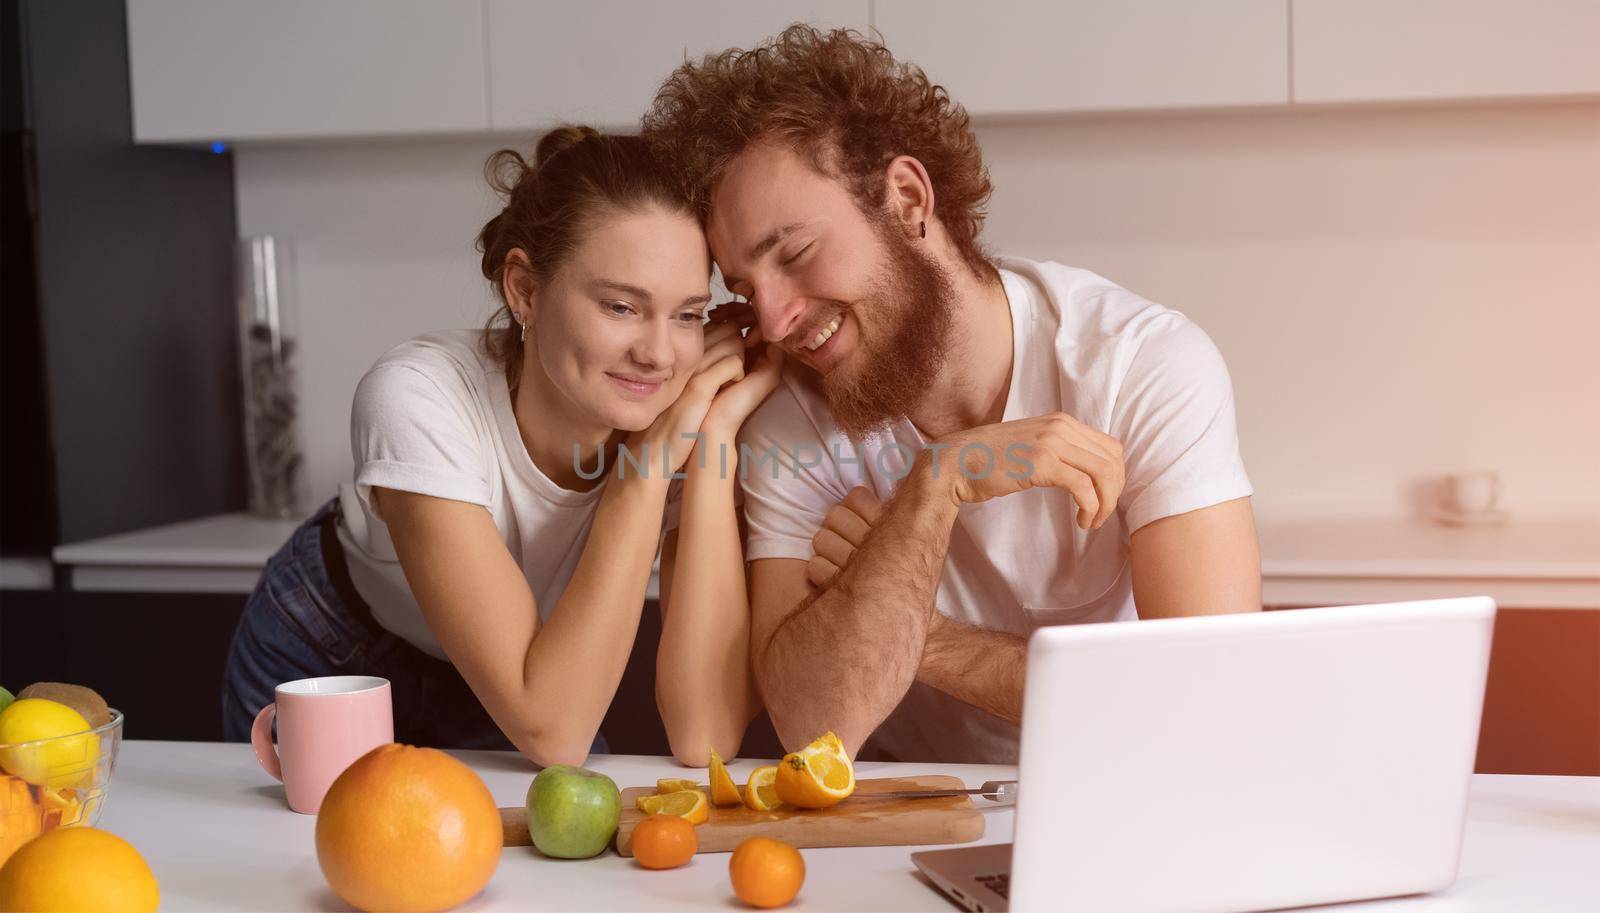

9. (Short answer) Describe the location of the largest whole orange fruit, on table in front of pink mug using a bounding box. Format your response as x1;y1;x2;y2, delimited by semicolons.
317;744;502;913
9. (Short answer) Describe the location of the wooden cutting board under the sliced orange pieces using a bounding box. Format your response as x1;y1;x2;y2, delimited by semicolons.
501;777;984;855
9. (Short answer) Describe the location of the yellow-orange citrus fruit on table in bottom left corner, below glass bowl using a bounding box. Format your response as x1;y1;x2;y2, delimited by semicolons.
0;827;162;913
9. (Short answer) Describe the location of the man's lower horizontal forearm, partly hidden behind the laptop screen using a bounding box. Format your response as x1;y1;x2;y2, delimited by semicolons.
917;612;1027;723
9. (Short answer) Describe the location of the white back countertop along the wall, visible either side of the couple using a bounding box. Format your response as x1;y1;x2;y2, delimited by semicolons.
54;513;1600;609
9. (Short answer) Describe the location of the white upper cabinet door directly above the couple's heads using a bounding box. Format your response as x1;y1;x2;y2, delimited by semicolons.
486;0;869;130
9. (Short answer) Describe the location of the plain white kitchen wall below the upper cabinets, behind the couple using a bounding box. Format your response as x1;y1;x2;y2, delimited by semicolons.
237;102;1600;513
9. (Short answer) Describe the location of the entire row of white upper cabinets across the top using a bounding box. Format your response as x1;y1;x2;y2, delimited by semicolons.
126;0;1600;142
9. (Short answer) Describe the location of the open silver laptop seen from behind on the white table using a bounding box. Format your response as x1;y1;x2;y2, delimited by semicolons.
912;596;1494;913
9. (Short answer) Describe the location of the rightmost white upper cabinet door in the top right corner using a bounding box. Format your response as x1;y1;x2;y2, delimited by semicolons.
1293;0;1600;102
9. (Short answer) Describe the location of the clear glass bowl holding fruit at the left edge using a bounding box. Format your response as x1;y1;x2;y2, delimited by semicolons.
0;708;122;863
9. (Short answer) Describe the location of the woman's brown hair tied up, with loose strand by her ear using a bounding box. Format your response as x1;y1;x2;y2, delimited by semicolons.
478;126;693;387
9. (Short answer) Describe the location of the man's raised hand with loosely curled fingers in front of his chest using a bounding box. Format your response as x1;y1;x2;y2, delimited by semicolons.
928;413;1126;529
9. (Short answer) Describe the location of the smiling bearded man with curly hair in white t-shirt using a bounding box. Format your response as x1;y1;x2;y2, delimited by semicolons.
643;26;1261;763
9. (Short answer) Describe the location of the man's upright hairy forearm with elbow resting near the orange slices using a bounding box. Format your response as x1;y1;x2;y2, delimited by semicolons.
755;465;957;753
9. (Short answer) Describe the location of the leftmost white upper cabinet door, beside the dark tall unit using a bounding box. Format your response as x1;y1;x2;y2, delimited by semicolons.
128;0;486;142
